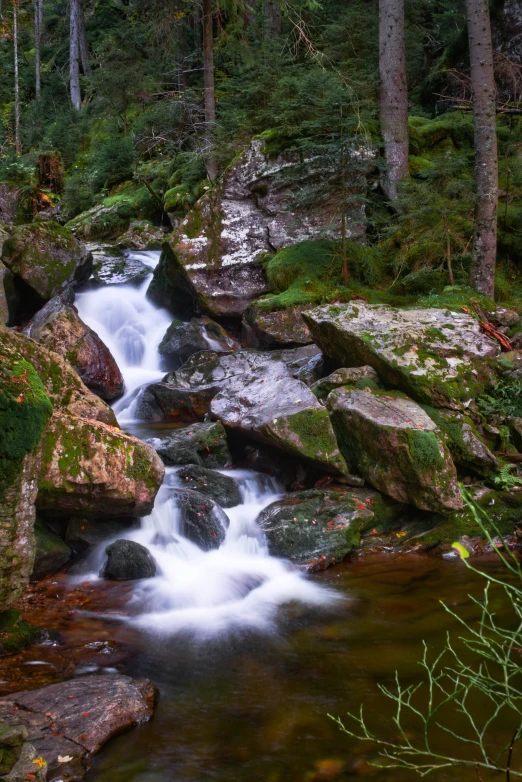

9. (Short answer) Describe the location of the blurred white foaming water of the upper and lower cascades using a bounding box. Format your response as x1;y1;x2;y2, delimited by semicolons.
73;253;338;638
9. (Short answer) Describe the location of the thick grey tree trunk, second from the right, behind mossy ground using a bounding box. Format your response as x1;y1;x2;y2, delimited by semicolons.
379;0;408;201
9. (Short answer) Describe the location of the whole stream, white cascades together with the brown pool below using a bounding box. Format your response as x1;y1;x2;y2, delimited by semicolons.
1;252;522;782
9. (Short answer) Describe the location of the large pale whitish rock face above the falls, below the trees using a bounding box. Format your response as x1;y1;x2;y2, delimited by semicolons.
144;139;370;317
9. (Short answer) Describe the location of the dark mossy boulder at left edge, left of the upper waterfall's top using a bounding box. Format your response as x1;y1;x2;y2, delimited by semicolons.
2;220;92;315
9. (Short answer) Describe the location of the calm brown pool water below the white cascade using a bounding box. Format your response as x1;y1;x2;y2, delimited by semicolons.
5;555;522;782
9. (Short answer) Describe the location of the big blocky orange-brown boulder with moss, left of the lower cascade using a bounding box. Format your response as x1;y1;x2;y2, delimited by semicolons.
37;412;164;517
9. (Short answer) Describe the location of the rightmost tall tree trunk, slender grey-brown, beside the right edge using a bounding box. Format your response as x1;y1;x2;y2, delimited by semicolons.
466;0;498;299
